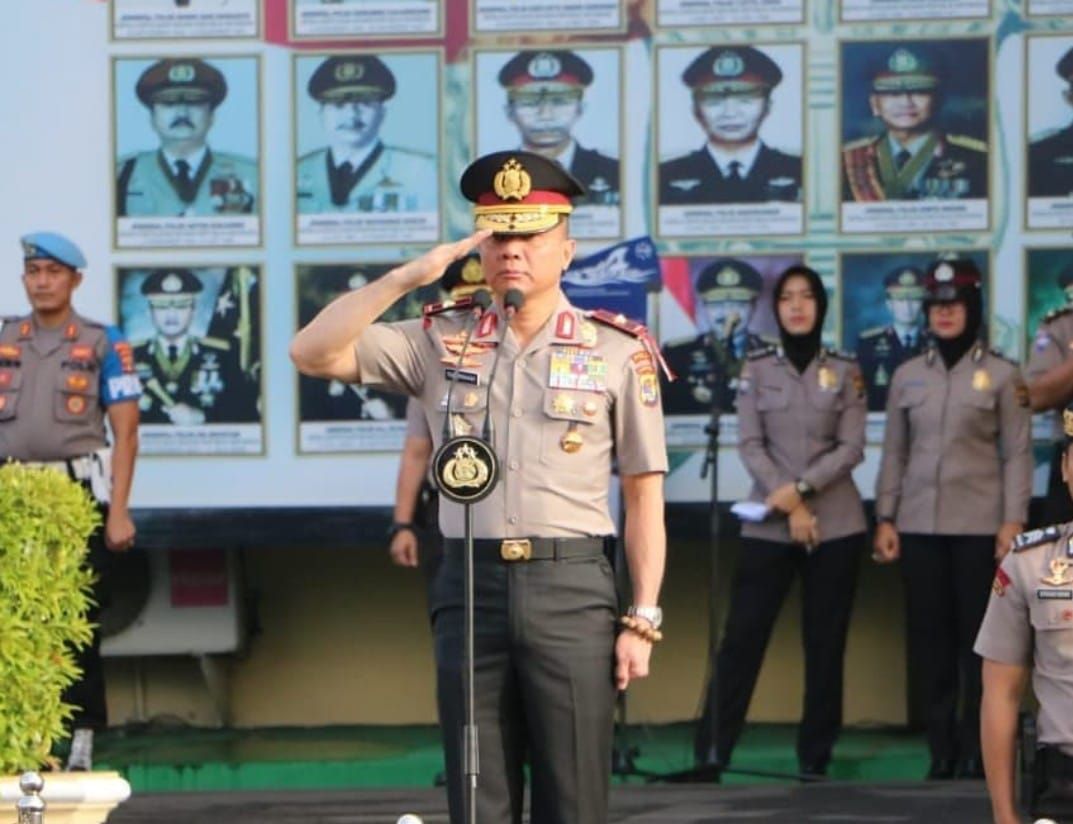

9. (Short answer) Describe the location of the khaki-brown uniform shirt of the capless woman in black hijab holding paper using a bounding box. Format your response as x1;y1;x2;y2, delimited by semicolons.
737;348;867;543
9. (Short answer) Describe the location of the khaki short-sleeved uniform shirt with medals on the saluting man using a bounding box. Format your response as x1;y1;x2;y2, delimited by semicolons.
356;295;667;539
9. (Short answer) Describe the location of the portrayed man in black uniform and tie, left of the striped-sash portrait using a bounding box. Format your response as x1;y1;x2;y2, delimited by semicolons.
659;46;802;206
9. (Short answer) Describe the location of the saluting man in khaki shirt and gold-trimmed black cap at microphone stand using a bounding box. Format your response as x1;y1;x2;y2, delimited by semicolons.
291;151;667;824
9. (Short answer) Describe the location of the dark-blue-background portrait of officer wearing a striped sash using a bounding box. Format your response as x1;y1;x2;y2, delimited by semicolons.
841;41;988;203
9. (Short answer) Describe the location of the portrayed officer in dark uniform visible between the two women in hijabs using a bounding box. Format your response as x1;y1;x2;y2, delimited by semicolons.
851;266;925;412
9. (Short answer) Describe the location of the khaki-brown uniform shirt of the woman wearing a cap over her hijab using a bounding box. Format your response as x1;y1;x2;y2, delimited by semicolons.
876;344;1032;535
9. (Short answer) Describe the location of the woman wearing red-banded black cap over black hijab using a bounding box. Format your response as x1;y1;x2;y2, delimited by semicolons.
873;260;1032;779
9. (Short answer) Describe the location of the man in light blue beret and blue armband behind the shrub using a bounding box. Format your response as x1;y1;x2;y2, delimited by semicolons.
0;232;141;769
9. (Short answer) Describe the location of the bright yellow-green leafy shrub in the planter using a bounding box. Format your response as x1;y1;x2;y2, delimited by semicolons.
0;462;101;775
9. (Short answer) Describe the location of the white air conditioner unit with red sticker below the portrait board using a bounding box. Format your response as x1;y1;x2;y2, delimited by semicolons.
101;549;242;657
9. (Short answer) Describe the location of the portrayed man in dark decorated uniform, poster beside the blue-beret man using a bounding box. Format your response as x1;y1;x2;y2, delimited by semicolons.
124;268;260;426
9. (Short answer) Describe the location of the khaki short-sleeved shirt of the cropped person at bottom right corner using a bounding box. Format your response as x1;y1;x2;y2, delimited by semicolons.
973;524;1073;756
